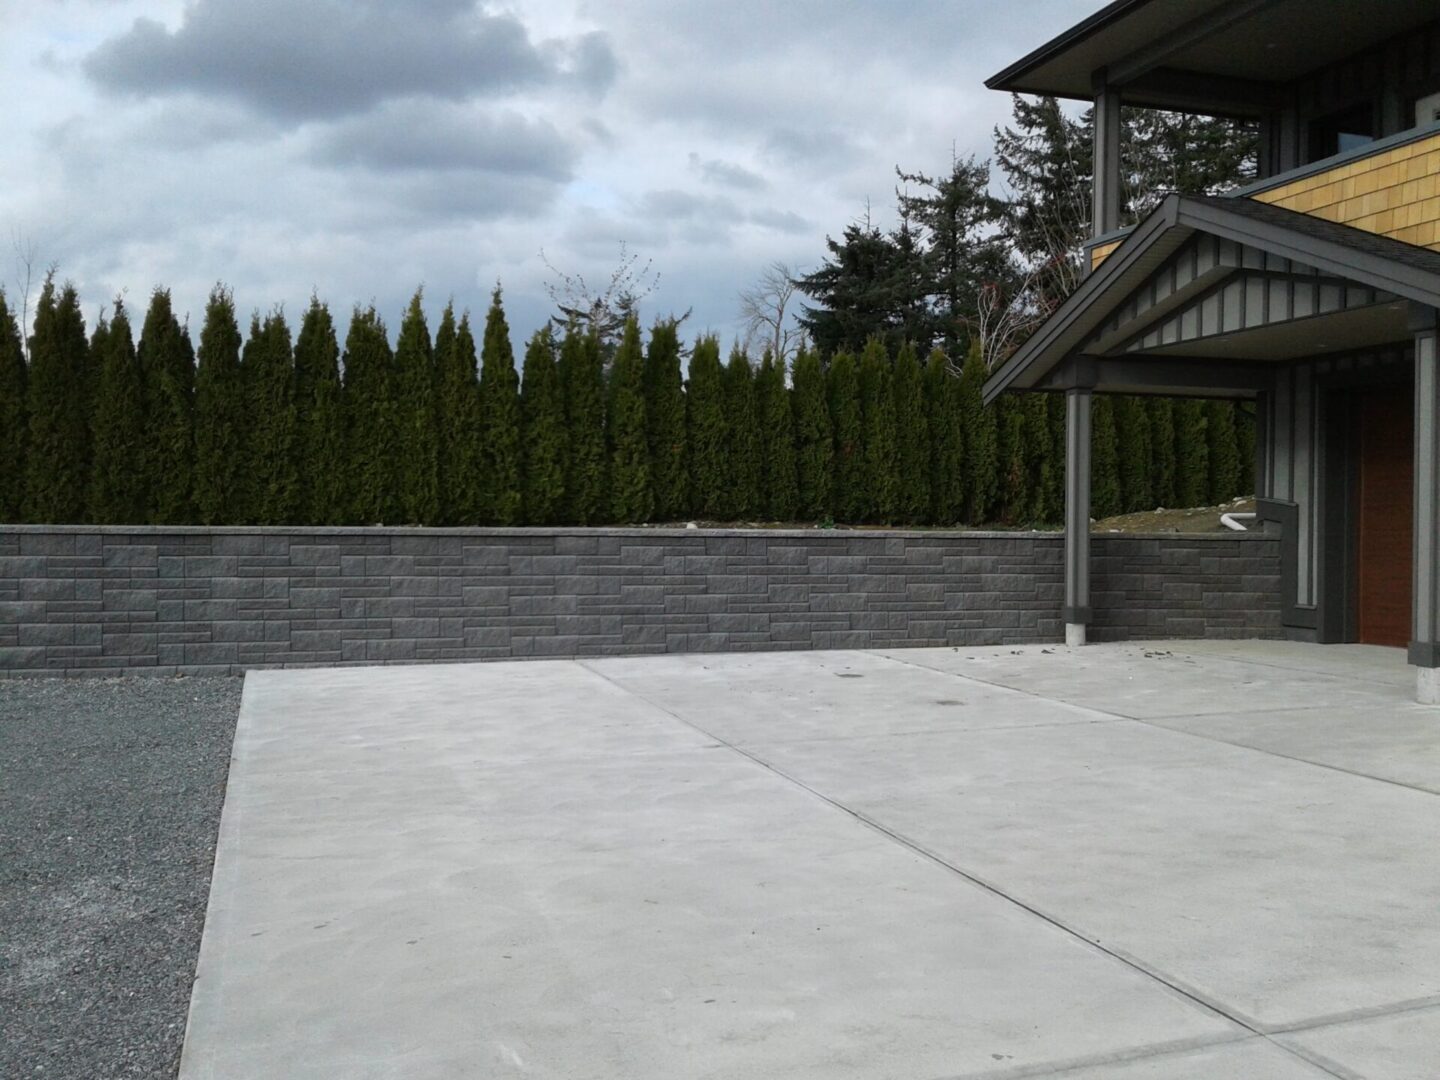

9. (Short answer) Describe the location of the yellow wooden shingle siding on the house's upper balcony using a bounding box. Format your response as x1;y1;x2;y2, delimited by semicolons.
1249;134;1440;253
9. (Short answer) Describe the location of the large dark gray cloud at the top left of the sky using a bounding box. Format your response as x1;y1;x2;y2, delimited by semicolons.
85;0;616;120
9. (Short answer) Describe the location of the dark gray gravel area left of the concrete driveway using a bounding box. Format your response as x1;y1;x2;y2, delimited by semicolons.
0;678;242;1080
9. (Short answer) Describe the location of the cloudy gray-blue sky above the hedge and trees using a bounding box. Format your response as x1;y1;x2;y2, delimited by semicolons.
0;0;1100;351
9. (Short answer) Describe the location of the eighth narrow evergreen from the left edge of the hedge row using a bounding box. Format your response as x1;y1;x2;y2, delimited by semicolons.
344;307;399;526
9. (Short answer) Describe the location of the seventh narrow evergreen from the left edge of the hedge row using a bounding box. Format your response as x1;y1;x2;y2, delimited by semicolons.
295;297;353;526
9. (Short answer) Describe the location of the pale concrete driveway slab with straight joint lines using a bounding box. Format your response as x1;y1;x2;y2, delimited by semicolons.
181;642;1440;1080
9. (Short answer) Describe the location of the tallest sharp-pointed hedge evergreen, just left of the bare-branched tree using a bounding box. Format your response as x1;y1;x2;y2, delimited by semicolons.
480;285;520;526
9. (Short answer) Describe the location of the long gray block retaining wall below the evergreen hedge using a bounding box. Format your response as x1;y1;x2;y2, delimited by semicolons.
0;526;1280;675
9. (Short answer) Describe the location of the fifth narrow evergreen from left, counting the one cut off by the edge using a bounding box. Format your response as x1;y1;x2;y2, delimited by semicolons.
194;285;245;526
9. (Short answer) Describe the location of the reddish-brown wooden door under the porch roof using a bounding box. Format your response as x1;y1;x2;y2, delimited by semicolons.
1356;390;1416;647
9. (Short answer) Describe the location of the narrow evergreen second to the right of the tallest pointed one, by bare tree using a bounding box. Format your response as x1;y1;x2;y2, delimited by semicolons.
560;323;608;526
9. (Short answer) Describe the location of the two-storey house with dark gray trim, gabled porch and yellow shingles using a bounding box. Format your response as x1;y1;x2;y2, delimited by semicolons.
985;0;1440;704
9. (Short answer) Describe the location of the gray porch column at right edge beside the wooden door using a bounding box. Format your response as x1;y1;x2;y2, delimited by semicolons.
1410;308;1440;706
